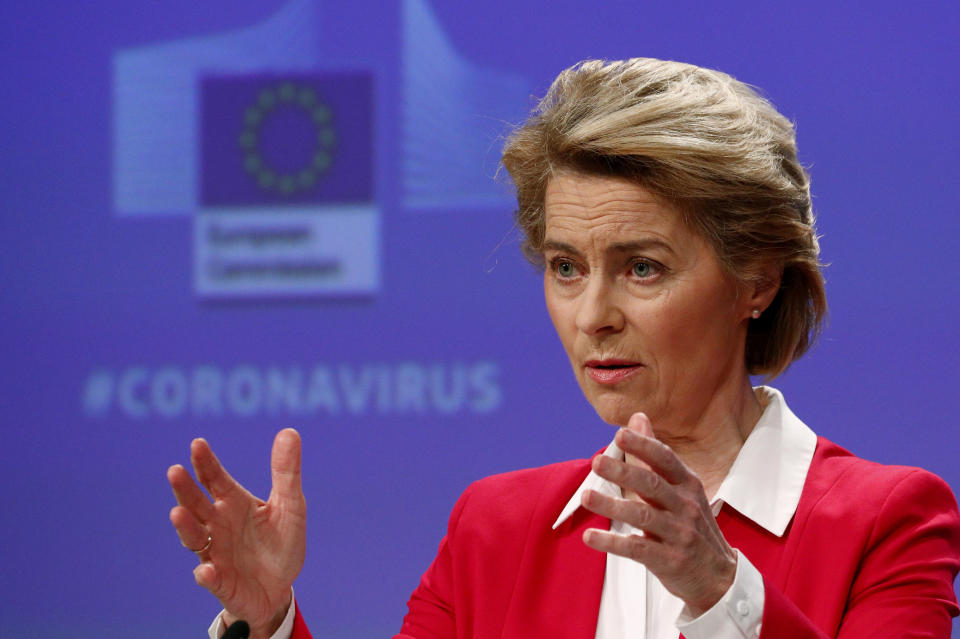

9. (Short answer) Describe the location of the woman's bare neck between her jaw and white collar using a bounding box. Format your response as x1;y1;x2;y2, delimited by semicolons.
628;375;766;500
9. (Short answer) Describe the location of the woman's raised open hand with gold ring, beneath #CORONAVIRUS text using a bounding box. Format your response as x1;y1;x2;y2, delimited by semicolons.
167;428;307;639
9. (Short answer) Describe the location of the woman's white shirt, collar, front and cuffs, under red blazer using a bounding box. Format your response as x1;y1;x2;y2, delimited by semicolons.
208;386;817;639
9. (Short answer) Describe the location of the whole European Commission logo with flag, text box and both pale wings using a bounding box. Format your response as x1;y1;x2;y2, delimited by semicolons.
112;0;530;299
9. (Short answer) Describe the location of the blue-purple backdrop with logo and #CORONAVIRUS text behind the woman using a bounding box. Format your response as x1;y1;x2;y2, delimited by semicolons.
0;0;960;639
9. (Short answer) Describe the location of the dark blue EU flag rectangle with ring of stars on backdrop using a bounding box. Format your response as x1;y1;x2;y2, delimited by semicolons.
200;72;373;208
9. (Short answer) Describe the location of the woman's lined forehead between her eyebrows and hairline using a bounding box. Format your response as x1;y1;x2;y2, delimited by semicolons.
544;173;692;241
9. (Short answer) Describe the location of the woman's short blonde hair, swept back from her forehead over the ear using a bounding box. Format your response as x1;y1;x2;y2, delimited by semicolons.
502;58;827;378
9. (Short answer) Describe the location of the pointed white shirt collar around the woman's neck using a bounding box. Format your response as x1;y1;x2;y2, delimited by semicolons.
553;386;817;537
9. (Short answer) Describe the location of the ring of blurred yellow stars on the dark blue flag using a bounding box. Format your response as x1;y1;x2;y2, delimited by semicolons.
239;82;337;195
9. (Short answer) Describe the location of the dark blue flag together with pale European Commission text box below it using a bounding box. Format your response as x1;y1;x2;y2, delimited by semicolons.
194;72;378;297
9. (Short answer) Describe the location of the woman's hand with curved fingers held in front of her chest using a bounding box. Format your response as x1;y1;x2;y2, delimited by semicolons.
582;413;737;616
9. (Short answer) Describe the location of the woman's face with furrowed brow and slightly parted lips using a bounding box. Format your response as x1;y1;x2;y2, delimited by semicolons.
543;173;756;430
